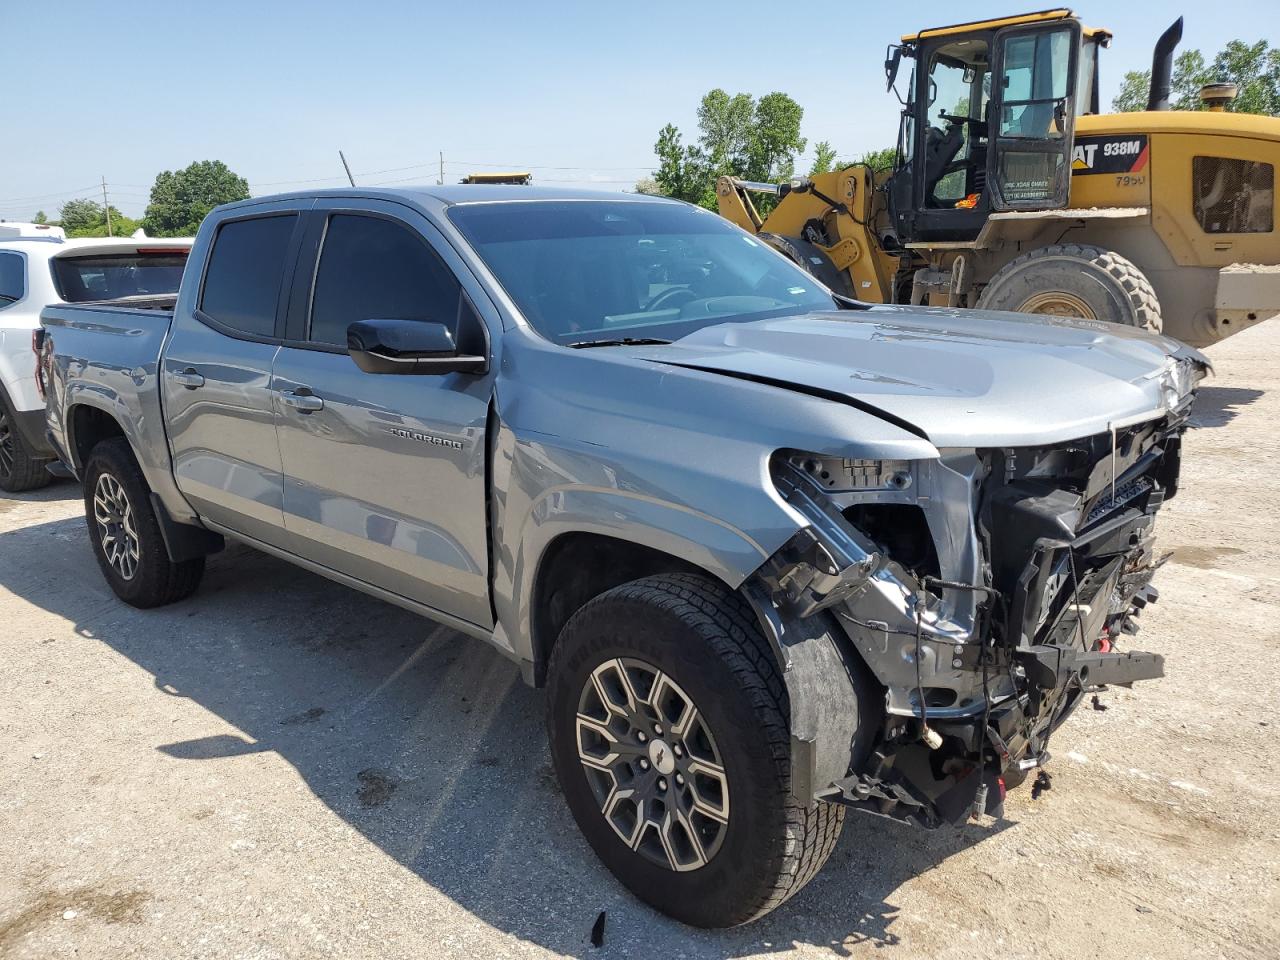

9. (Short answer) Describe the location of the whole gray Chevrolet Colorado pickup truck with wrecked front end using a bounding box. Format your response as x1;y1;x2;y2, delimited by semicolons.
38;186;1207;925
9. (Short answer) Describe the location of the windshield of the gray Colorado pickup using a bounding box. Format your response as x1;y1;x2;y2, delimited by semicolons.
449;200;836;344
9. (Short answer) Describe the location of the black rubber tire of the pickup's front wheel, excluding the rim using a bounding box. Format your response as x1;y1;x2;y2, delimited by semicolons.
548;575;845;928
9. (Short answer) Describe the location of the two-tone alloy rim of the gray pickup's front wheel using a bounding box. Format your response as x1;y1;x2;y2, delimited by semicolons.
576;658;730;872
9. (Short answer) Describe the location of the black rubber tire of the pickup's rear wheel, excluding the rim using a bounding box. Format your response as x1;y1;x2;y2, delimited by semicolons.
84;436;205;609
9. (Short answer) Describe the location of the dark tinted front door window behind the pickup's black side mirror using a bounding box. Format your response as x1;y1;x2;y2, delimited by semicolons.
308;214;461;347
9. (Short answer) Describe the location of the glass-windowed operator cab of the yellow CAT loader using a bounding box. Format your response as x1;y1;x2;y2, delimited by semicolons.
886;10;1096;244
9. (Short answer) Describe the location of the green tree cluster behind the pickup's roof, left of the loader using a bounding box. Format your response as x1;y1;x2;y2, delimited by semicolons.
637;90;805;210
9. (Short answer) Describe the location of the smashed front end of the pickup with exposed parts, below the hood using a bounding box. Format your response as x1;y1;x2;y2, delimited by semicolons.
748;394;1192;827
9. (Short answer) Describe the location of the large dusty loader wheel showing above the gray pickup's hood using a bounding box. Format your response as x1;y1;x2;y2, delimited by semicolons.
978;243;1162;333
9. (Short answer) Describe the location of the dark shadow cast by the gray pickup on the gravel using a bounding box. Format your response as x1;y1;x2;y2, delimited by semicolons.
0;517;1008;957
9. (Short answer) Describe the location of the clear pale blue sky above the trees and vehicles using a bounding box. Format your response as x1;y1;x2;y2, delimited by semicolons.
0;0;1280;220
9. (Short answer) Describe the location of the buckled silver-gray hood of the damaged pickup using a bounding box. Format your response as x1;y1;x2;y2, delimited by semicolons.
632;307;1210;447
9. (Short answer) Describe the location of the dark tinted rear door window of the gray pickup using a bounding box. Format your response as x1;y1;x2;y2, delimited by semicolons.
200;214;298;337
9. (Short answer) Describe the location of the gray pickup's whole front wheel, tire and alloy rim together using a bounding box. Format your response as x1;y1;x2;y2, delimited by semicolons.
548;575;845;927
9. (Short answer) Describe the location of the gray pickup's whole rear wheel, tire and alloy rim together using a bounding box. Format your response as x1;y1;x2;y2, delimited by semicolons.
84;436;205;608
